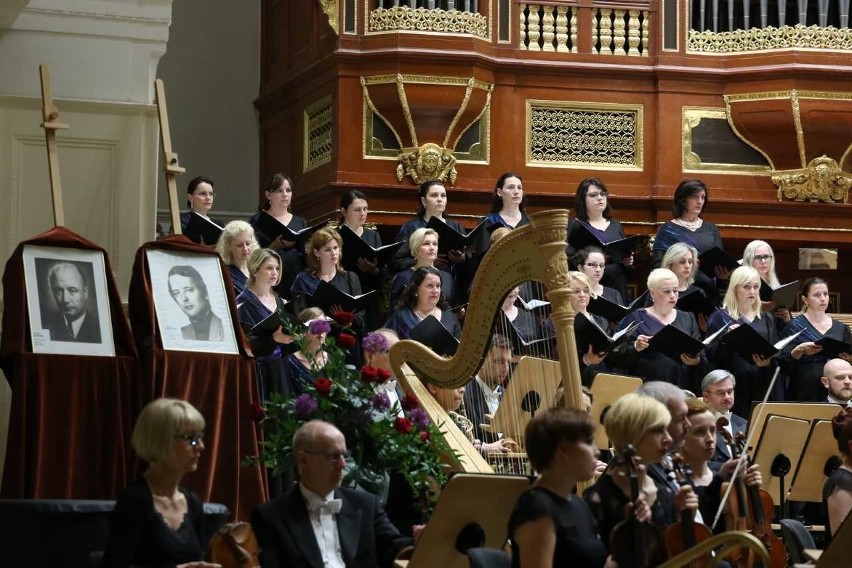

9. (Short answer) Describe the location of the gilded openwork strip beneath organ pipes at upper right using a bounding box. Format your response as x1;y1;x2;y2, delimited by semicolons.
686;24;852;54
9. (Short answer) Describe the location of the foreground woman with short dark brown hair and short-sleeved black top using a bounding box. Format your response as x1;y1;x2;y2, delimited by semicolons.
509;407;613;568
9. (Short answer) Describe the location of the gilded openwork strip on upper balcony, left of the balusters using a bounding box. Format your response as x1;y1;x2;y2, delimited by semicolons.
367;6;489;39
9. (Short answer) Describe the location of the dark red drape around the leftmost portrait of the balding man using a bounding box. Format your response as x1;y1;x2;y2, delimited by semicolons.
0;227;141;499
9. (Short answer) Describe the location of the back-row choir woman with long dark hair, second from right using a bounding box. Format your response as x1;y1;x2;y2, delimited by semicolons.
568;178;633;298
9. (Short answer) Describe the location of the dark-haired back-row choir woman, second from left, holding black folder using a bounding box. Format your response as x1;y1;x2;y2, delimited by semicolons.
249;173;308;295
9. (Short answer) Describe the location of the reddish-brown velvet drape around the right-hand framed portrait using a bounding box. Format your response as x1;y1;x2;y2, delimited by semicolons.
128;236;267;520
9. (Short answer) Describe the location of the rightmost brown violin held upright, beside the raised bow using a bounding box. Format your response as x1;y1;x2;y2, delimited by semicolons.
716;417;787;568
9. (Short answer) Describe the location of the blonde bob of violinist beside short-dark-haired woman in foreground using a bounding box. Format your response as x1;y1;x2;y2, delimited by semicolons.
604;392;672;452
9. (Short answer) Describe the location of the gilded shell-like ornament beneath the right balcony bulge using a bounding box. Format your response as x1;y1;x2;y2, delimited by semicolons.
772;155;852;203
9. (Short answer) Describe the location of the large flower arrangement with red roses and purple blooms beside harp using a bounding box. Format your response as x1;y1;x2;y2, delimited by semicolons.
247;312;452;503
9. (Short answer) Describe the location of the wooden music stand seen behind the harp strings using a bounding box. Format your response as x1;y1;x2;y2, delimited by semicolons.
481;357;562;450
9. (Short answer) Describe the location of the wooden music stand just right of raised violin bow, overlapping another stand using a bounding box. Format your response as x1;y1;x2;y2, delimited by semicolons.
752;415;811;507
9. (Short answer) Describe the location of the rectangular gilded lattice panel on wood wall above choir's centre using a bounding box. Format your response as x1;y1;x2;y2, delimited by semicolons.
526;100;644;171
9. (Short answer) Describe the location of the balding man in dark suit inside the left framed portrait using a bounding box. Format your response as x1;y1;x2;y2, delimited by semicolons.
45;261;101;343
